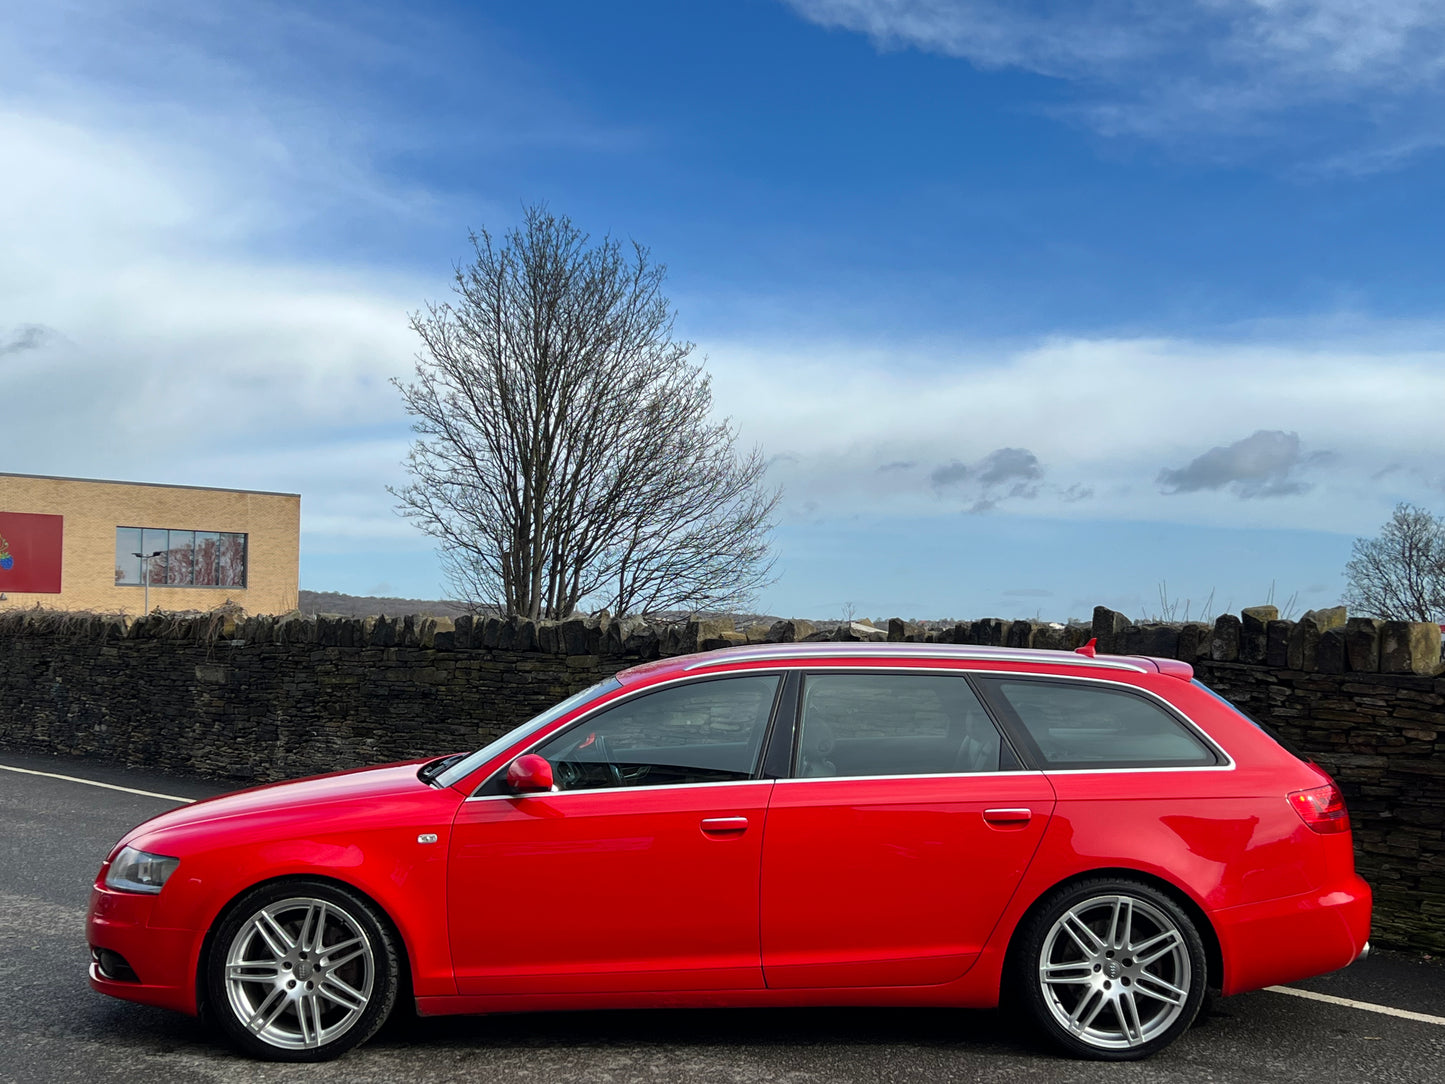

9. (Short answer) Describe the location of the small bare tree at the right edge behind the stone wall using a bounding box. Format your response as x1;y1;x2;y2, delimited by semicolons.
1345;504;1445;621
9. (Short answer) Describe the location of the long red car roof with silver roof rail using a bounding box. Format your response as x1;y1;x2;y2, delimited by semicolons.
617;640;1194;685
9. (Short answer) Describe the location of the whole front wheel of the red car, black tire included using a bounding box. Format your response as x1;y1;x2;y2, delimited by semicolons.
204;879;400;1061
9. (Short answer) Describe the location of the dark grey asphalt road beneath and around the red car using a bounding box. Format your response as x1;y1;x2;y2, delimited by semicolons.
0;753;1445;1084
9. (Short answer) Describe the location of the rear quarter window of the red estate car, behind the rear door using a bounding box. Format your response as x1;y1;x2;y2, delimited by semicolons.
978;678;1221;769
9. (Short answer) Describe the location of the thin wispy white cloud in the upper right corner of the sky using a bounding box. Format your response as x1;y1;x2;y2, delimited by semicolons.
786;0;1445;172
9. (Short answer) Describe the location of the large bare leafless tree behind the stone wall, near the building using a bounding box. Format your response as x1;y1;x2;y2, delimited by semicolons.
392;207;780;617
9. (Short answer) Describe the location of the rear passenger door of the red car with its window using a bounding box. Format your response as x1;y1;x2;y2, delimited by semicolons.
762;668;1053;987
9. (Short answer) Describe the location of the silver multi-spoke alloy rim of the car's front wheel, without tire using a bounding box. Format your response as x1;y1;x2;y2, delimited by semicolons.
225;896;376;1051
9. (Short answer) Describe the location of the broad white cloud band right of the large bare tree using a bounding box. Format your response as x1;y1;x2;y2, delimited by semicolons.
705;325;1445;533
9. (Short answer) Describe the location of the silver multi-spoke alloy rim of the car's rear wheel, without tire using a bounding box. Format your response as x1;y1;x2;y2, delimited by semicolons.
1038;895;1194;1051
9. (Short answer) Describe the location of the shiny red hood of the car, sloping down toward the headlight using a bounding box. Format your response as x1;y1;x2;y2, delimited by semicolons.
118;757;435;846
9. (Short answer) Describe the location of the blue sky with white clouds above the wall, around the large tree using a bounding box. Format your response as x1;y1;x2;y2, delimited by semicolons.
0;0;1445;619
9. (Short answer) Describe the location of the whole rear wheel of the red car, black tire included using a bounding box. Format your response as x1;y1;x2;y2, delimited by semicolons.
1009;877;1208;1061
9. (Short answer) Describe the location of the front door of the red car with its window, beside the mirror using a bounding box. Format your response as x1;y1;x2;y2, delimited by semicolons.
448;671;780;994
